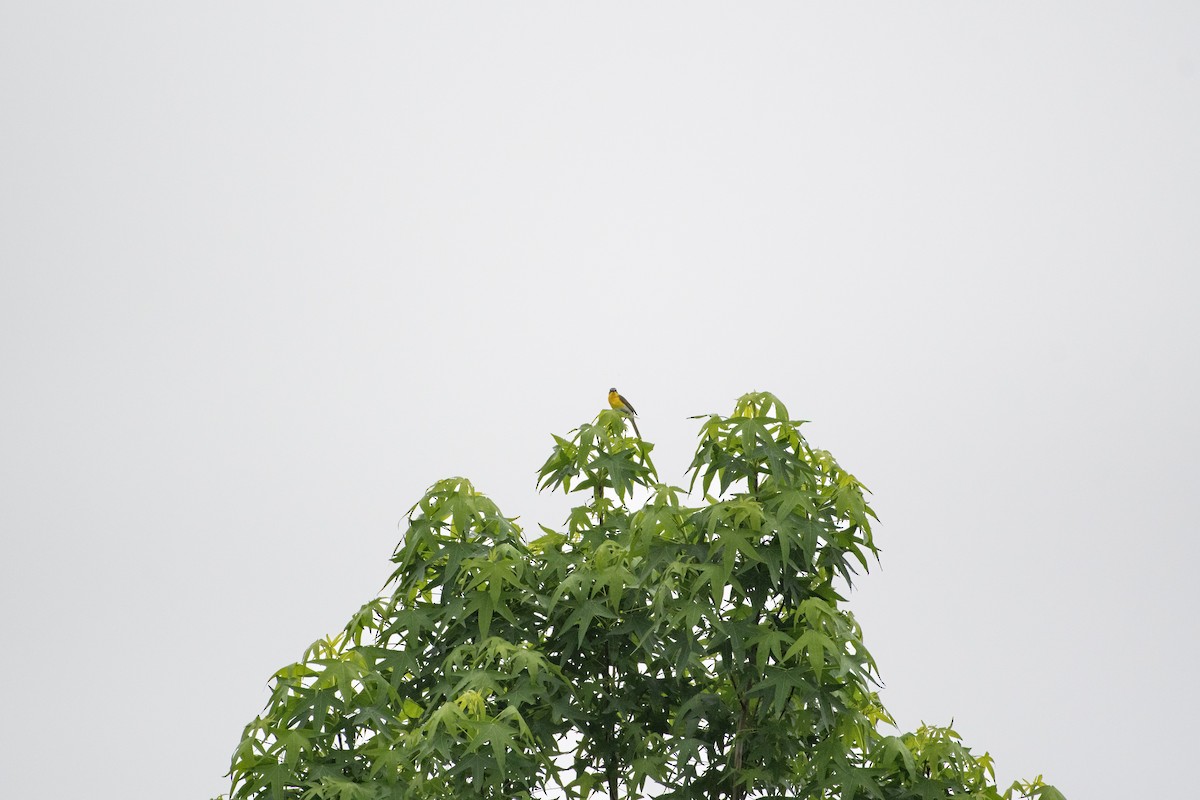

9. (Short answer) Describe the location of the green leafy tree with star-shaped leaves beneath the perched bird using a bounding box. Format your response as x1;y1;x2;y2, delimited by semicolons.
220;392;1062;800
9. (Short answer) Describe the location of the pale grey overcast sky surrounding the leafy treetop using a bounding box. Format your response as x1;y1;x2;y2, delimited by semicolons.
0;1;1200;800
